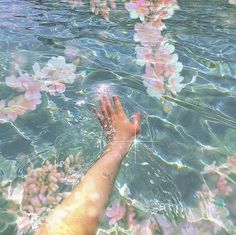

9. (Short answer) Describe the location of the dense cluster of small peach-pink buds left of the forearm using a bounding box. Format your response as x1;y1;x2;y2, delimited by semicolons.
13;155;83;233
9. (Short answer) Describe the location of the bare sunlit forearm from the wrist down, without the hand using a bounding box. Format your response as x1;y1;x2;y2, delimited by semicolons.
37;142;132;235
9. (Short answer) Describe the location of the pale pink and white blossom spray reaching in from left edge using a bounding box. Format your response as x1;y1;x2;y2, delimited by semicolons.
0;56;77;123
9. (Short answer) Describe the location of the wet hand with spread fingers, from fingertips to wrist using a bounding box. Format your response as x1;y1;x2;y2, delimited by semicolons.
94;96;141;143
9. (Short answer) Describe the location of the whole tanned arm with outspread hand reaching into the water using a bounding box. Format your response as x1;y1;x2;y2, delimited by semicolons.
36;96;141;235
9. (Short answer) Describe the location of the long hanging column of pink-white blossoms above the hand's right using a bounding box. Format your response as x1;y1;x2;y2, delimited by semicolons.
125;0;189;98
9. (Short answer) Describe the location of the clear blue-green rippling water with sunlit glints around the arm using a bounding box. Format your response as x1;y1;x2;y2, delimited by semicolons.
0;0;236;235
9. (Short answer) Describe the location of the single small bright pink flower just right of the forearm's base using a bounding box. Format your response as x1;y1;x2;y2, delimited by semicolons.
106;202;126;225
